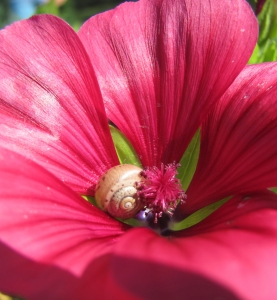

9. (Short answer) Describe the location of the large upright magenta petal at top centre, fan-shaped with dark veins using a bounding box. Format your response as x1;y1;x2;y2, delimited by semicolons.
79;0;257;166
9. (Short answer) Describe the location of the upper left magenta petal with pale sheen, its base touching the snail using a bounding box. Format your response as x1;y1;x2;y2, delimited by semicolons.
0;15;118;193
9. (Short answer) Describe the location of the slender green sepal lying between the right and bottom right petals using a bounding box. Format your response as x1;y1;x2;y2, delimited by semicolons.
170;197;231;231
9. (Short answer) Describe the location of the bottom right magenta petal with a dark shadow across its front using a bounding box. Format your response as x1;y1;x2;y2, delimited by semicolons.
113;194;277;300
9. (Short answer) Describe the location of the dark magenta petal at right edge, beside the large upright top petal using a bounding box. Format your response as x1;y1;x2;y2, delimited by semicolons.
178;63;277;215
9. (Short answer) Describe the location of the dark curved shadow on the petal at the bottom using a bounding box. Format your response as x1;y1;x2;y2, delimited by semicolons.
110;256;240;300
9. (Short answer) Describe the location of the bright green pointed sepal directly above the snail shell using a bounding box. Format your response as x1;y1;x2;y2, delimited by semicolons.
110;125;141;167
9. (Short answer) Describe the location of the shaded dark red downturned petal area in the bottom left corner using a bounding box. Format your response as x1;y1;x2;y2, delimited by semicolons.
0;246;139;300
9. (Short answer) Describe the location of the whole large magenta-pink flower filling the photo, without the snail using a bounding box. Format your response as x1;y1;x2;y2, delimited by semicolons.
0;0;277;300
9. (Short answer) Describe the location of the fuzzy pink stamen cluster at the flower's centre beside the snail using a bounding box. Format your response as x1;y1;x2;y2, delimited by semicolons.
137;163;187;223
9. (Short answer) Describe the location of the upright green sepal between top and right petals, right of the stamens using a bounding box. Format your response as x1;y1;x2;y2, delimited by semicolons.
177;129;200;191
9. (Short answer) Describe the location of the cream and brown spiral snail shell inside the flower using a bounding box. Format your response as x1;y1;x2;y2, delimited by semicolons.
95;164;143;219
